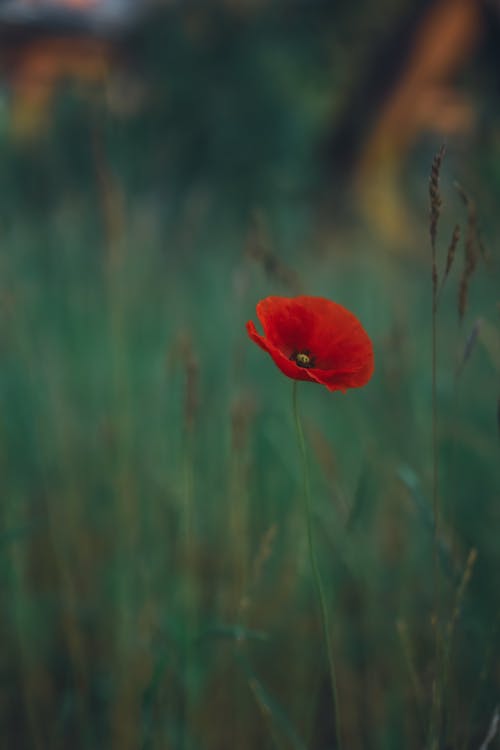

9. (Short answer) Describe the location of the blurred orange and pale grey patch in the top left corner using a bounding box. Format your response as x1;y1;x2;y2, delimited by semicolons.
0;0;141;141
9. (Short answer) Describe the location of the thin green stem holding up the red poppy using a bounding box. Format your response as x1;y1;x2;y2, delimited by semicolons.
292;380;342;750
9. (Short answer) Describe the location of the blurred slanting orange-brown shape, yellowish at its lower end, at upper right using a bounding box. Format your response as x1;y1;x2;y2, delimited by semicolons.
355;0;482;243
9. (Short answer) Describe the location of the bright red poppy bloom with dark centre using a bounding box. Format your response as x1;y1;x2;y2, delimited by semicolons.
247;296;374;391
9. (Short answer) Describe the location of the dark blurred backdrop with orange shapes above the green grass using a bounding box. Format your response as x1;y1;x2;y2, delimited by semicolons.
0;0;500;243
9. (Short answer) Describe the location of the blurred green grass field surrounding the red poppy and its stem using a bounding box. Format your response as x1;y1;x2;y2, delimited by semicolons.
0;4;500;750
